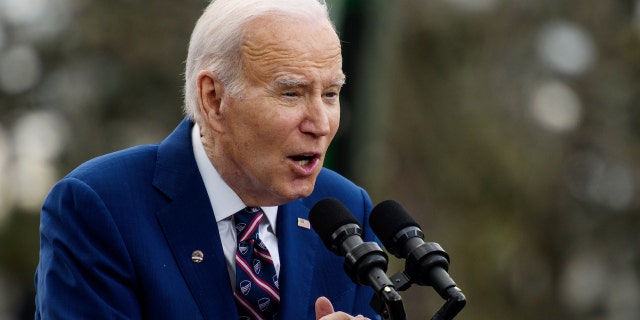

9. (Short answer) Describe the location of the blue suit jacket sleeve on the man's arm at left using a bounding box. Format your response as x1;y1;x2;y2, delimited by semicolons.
35;178;141;319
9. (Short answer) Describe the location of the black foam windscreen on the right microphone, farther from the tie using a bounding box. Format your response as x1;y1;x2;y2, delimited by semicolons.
369;200;420;250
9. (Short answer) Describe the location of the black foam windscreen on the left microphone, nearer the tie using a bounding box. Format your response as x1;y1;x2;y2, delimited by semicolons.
309;198;360;248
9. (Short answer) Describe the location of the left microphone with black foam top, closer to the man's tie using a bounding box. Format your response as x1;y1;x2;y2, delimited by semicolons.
309;198;395;293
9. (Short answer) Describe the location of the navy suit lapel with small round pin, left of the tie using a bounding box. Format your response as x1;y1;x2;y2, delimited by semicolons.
154;120;238;319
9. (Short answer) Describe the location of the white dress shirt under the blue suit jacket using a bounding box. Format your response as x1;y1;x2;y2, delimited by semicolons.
191;124;280;286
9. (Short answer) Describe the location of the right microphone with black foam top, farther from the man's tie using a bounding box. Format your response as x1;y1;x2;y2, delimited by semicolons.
369;200;464;300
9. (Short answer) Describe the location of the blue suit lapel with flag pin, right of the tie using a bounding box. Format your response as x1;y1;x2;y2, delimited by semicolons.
277;200;320;319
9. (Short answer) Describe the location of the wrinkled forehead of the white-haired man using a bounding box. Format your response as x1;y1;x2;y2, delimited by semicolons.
242;16;344;81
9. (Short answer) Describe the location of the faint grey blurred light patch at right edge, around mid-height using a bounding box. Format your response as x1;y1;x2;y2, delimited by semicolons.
568;152;636;210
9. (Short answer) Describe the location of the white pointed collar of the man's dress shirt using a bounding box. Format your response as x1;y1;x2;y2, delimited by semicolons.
191;123;278;233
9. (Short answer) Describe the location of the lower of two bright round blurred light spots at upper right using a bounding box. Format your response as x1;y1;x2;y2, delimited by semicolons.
529;81;582;133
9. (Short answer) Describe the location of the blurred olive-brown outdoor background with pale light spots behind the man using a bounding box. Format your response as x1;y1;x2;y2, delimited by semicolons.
0;0;640;320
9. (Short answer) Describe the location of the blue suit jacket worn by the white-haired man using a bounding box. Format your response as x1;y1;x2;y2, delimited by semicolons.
35;120;377;320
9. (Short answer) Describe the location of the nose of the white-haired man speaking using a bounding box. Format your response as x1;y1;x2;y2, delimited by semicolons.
300;97;340;137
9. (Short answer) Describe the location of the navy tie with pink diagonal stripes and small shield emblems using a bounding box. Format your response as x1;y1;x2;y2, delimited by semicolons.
233;208;280;320
